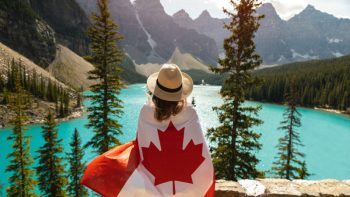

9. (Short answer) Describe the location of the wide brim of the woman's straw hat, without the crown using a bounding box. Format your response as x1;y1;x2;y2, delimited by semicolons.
147;72;193;101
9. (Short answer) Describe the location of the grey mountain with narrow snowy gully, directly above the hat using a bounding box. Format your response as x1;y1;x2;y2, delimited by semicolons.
77;0;218;64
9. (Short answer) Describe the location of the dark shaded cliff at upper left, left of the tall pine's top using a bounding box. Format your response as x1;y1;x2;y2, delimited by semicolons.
29;0;90;55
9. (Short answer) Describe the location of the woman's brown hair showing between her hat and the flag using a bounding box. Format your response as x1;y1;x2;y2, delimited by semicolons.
152;95;185;122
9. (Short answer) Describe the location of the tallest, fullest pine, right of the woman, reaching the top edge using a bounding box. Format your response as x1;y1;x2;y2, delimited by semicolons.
207;0;263;180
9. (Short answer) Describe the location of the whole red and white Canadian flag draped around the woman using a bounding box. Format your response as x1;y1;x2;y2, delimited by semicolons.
81;103;215;197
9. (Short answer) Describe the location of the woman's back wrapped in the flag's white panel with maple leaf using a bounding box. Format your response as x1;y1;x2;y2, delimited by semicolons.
133;102;214;196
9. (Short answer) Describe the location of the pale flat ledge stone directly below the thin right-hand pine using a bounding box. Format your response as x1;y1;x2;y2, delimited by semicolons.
259;179;302;197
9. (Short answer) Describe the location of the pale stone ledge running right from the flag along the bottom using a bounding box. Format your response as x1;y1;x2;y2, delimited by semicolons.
215;179;350;197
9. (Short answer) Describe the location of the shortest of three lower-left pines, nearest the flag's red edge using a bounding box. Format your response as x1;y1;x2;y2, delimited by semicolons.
67;129;87;197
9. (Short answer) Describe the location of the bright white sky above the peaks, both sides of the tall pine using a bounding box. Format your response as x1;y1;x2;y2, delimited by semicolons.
160;0;350;20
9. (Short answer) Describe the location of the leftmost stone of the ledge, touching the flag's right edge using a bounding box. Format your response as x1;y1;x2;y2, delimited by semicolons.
215;180;245;197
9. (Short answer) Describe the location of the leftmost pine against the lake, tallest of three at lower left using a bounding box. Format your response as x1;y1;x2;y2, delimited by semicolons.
6;64;37;197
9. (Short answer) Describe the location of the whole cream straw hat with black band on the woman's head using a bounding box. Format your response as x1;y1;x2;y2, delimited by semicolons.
147;64;193;101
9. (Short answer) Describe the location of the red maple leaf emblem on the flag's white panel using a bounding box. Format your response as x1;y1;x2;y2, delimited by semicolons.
142;121;205;195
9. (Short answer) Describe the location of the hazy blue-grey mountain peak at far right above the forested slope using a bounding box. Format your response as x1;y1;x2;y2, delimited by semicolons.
287;5;350;59
